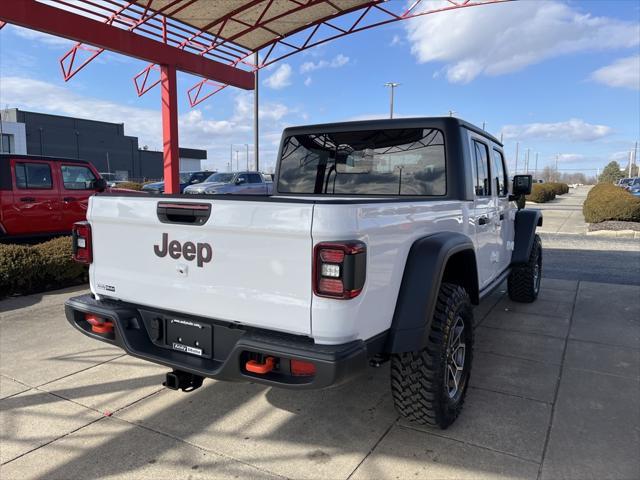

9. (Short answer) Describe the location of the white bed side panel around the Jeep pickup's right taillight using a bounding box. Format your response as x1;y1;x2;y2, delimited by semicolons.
311;200;477;344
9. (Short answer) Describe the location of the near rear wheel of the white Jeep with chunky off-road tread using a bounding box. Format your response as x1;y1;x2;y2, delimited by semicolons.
391;283;473;429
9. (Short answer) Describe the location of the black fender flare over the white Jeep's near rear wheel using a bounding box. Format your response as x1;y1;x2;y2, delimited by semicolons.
385;232;478;353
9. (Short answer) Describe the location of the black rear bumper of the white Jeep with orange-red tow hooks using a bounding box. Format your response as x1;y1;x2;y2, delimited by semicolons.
65;295;376;389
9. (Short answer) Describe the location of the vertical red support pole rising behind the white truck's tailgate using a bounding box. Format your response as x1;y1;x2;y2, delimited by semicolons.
160;65;180;194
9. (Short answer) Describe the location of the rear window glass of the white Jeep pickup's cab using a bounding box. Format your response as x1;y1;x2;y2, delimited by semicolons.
278;128;446;196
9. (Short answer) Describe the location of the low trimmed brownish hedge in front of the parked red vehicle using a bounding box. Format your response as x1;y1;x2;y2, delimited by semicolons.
0;237;88;298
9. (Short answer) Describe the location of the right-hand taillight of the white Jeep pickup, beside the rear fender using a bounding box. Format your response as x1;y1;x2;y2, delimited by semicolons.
313;241;367;300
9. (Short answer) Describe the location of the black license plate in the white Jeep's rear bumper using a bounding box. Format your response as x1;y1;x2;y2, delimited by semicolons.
166;318;213;358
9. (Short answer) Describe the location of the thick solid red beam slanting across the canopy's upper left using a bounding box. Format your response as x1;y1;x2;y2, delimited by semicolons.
0;0;254;90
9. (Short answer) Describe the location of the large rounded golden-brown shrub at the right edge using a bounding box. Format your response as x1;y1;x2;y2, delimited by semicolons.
582;183;640;223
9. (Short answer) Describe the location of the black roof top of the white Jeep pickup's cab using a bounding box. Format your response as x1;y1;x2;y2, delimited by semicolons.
283;117;503;146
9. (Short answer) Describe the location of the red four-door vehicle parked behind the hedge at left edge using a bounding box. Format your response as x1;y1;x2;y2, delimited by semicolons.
0;154;106;242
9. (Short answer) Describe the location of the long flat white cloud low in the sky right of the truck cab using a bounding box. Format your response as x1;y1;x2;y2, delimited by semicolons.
501;118;612;142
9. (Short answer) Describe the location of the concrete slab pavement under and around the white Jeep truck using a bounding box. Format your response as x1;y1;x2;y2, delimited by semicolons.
0;278;640;479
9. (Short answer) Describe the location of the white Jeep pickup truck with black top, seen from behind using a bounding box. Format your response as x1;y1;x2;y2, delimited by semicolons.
66;117;542;428
